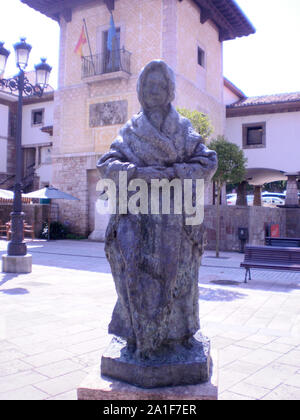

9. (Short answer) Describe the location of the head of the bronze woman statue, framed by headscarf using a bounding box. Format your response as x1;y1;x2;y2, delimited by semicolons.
137;60;175;110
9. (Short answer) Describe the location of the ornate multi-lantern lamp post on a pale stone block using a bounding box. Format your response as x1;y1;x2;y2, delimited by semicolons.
0;38;51;273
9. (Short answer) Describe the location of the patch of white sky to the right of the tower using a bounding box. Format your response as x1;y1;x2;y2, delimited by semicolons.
223;0;300;96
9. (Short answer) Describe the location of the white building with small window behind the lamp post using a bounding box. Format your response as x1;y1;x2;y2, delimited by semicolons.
0;72;54;192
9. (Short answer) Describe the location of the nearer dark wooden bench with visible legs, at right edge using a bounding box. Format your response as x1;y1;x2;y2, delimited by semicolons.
240;245;300;283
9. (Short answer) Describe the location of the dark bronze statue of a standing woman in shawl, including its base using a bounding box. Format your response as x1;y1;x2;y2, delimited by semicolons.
97;60;217;387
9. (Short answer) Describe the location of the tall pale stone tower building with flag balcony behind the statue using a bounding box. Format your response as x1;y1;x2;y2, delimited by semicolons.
22;0;254;239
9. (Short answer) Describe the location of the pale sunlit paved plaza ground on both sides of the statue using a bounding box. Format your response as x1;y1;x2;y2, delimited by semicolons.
0;240;300;400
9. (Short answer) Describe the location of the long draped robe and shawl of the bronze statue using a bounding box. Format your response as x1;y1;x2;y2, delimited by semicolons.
97;106;217;355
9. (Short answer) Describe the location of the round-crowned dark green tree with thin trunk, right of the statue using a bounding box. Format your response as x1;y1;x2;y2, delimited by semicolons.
209;136;247;257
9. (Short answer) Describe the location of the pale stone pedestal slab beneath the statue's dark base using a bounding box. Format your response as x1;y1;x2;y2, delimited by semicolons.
77;352;218;401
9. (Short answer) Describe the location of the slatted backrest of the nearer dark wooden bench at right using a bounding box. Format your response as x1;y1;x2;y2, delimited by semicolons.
245;245;300;264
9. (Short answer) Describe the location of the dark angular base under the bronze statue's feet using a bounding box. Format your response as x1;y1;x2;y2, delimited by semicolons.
101;333;211;388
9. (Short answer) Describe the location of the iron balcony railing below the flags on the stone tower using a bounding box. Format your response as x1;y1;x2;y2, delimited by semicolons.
82;48;131;79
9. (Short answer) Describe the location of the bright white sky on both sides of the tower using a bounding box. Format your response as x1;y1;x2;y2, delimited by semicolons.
0;0;300;96
